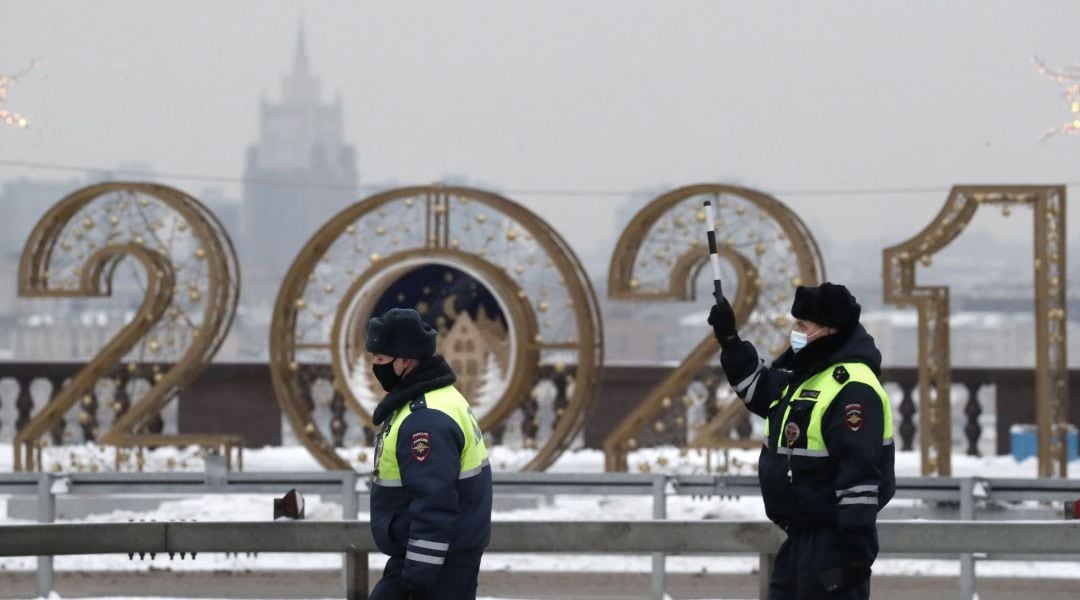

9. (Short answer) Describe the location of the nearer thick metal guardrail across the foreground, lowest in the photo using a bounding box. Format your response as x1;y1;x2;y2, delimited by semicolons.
0;520;1080;600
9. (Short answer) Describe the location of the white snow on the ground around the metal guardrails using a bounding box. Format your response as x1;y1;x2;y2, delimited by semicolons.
0;446;1080;600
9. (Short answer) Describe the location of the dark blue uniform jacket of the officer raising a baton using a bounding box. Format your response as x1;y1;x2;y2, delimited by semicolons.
720;325;896;564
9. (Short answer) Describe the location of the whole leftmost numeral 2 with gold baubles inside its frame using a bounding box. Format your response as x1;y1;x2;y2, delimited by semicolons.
14;182;239;469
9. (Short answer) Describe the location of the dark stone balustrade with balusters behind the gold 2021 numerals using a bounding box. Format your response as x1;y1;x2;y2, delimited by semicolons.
0;360;1080;455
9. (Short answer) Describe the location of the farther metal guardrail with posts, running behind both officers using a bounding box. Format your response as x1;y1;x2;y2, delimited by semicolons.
0;468;1080;599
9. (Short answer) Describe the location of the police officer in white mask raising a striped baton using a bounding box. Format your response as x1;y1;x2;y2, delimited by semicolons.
708;283;896;600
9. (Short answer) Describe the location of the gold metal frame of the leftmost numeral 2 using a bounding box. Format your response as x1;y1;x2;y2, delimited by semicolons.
13;182;239;471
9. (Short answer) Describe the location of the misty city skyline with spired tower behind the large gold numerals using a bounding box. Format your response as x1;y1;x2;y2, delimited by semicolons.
0;16;1080;367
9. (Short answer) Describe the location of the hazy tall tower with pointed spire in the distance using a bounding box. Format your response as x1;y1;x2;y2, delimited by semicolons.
241;25;359;293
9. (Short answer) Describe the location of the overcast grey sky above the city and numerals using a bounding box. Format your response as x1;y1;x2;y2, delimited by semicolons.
0;0;1080;270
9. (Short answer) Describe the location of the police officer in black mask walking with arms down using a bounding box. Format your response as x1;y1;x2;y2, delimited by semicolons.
366;309;491;600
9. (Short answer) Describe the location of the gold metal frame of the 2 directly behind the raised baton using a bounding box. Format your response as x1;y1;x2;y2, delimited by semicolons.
604;183;825;471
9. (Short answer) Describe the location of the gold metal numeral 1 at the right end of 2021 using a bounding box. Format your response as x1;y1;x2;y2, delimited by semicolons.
882;186;1068;477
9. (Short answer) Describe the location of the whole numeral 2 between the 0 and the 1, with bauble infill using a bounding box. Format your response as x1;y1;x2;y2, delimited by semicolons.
604;185;824;471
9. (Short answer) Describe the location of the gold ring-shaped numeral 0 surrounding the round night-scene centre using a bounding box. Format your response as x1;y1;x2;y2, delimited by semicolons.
270;186;603;469
